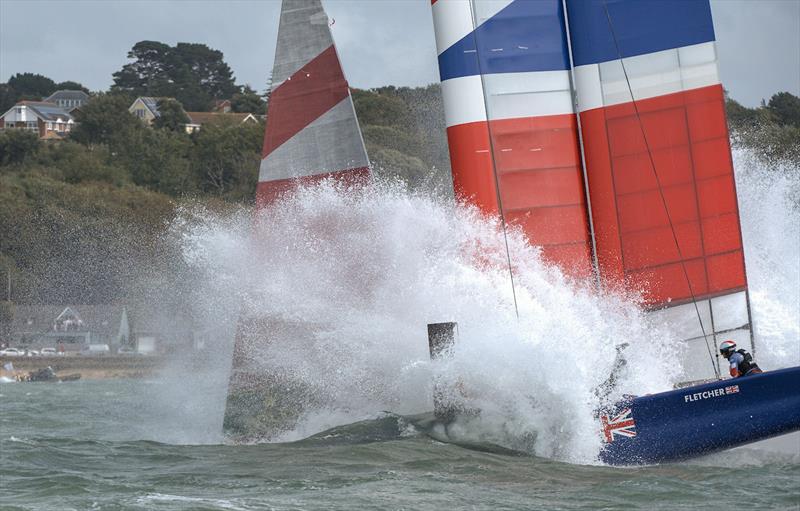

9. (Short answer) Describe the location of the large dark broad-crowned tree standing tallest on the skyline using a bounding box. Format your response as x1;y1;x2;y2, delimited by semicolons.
112;41;237;112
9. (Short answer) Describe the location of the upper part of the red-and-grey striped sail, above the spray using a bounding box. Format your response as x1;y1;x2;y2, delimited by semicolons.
256;0;370;207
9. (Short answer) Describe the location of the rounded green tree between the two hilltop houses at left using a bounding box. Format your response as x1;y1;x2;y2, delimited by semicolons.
70;94;145;145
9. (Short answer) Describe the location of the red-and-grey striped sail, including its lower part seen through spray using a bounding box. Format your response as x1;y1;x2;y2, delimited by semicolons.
224;0;370;439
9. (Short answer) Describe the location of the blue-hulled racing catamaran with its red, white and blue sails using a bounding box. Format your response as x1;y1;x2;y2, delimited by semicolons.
432;0;800;464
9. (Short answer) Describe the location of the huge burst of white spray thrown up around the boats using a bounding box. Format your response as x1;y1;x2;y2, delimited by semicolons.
165;146;800;463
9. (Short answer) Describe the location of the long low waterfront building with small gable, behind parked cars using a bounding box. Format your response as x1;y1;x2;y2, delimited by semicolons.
11;305;131;352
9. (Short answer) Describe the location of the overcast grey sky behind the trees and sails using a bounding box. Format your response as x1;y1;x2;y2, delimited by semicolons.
0;0;800;106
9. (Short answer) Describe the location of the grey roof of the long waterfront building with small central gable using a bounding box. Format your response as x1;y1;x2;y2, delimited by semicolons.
11;305;125;336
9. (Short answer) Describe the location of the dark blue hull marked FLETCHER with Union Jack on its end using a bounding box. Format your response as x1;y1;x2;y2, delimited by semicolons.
600;367;800;465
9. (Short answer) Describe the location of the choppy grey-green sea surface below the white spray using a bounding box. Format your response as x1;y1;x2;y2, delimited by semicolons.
0;381;800;510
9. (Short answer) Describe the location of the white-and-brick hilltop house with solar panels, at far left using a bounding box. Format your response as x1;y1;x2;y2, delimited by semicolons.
0;101;75;139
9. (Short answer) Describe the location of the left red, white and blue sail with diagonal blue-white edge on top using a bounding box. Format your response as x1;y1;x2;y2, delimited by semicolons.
432;0;591;276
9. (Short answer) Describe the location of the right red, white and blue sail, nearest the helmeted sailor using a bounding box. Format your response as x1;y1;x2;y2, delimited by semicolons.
566;0;752;377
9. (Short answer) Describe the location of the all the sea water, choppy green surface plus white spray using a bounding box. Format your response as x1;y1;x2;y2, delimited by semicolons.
0;147;800;509
